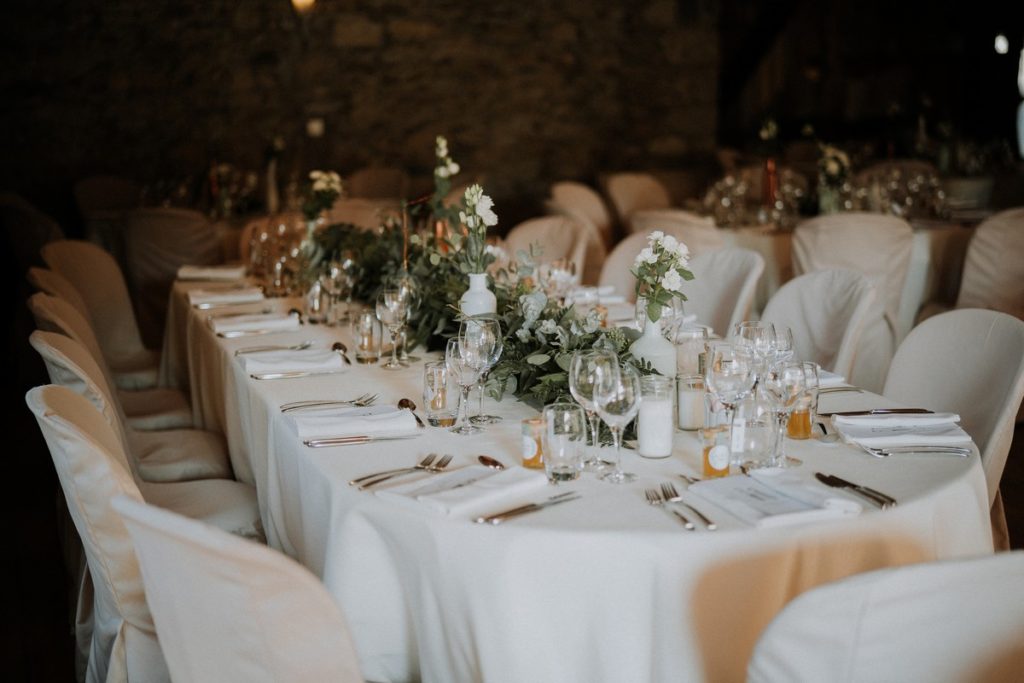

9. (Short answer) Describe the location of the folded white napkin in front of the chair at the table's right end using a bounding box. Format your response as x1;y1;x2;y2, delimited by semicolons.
833;413;971;447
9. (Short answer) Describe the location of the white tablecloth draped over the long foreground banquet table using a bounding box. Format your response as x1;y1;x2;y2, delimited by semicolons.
170;283;992;683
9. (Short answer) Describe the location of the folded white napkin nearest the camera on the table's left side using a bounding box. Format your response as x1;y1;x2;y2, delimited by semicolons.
377;465;548;516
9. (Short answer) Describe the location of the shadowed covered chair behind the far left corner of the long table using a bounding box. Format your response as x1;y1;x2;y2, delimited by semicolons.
125;208;224;348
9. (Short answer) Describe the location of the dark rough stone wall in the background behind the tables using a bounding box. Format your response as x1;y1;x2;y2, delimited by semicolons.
0;0;719;229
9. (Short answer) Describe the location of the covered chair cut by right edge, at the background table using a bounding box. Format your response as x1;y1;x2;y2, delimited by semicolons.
956;208;1024;319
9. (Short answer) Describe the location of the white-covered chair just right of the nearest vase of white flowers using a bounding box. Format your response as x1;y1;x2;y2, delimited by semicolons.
683;247;765;337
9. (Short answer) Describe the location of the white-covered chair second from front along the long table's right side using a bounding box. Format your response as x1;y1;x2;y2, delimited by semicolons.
761;270;874;377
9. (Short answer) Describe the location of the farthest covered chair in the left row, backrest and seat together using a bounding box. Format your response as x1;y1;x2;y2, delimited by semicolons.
39;240;160;389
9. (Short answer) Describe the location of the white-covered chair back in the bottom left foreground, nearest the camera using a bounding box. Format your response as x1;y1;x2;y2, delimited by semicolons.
114;497;362;683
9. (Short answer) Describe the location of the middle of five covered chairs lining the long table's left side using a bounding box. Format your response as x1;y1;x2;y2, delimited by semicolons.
29;292;193;430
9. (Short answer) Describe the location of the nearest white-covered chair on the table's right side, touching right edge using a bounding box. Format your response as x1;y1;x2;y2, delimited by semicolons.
882;308;1024;547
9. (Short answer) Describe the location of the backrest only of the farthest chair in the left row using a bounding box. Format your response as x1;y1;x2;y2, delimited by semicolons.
42;240;145;366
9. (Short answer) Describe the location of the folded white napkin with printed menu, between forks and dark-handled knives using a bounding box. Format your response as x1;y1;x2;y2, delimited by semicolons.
689;470;862;528
